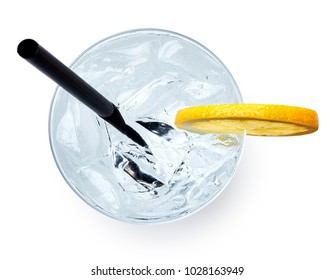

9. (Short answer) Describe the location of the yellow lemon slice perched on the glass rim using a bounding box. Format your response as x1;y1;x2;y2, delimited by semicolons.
175;104;319;136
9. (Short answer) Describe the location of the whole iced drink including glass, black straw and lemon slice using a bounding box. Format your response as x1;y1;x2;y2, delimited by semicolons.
17;29;319;223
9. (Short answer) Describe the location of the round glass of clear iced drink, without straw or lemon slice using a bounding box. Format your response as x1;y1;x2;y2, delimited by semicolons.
49;29;244;223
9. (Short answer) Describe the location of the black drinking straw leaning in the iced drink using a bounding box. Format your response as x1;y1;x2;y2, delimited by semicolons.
17;39;147;147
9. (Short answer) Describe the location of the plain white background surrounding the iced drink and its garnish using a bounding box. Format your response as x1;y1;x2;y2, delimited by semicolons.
0;0;335;280
